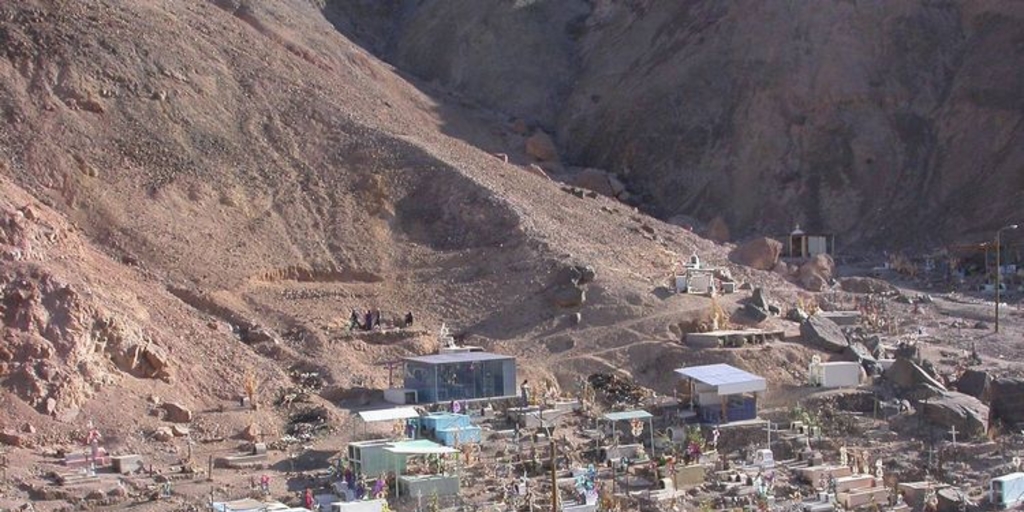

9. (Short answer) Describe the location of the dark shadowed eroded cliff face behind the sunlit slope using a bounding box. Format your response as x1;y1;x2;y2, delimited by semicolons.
329;0;1024;245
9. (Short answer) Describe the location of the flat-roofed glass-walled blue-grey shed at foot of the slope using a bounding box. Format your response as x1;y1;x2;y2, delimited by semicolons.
404;352;516;403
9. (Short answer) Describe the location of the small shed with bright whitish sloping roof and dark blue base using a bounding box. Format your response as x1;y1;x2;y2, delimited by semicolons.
676;365;768;424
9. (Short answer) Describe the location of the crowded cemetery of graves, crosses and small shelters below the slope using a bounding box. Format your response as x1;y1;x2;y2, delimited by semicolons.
2;260;1024;512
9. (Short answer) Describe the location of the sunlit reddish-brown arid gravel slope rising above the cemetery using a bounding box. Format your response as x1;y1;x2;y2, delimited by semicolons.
0;0;775;421
